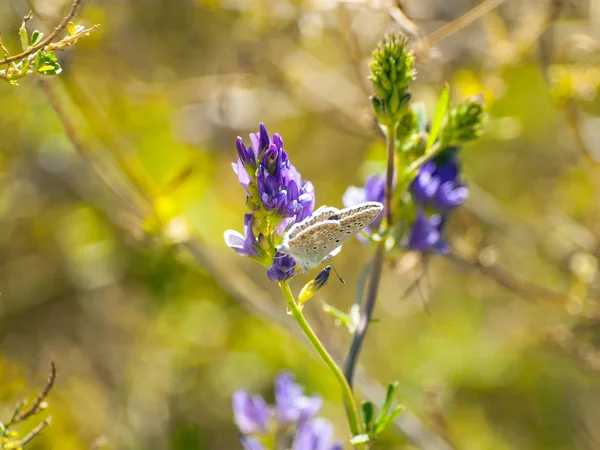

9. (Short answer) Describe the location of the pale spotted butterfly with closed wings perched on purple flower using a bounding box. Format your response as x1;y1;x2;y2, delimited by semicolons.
277;202;383;272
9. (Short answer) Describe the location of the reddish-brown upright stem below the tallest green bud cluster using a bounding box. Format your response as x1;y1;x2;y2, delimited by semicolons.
344;124;396;386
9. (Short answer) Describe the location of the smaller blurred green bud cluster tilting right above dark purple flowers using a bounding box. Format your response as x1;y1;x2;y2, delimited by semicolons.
439;96;485;147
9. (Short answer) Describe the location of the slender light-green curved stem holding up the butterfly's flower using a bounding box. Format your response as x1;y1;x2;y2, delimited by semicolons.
279;281;362;436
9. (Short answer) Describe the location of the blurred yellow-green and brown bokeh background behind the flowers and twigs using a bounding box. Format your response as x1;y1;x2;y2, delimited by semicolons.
0;0;600;450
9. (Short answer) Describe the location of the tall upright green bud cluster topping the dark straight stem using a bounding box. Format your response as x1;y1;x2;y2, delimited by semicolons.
369;33;416;126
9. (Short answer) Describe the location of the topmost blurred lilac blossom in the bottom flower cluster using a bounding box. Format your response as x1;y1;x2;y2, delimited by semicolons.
275;372;323;423
